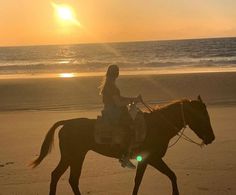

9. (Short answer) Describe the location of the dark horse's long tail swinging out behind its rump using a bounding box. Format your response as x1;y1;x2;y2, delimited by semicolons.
30;121;65;168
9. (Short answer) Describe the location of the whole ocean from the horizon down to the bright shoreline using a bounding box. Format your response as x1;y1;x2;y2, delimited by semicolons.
0;38;236;78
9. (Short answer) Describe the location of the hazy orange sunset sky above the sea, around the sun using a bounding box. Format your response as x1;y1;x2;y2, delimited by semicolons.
0;0;236;46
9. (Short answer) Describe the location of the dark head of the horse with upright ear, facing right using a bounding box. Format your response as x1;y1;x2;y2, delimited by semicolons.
186;96;215;145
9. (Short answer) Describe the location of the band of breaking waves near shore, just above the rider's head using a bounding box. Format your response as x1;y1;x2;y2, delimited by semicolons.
0;58;236;74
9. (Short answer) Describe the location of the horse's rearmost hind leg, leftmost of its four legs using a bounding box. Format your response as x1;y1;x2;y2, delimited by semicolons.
49;159;69;195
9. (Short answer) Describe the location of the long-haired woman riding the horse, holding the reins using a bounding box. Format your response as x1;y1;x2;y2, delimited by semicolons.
100;65;142;168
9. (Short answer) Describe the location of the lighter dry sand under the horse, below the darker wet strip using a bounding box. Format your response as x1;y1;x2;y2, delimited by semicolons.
0;106;236;195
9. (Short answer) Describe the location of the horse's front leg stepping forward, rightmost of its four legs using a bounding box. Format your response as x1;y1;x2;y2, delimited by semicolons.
149;158;179;195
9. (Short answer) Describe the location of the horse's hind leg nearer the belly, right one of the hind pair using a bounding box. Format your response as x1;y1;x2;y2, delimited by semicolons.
69;155;85;195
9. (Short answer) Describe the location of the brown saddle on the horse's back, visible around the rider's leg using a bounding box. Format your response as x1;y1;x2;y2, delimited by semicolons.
94;105;147;147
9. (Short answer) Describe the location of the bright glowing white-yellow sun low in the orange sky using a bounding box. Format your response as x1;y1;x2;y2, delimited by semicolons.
51;2;80;25
